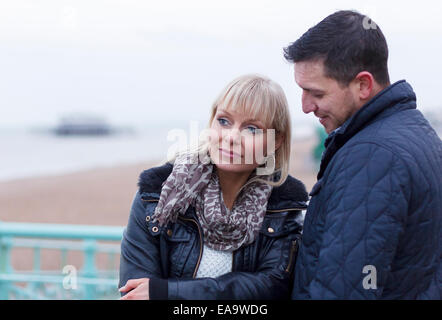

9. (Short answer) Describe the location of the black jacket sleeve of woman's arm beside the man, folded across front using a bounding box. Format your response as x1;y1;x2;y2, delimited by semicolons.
168;212;301;300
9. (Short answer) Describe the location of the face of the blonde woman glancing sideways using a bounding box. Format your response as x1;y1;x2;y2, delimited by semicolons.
209;108;275;172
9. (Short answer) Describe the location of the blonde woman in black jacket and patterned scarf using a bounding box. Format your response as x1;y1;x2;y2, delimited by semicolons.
120;75;307;300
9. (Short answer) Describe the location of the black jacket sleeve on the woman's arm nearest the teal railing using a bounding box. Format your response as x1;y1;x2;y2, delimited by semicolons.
119;192;161;287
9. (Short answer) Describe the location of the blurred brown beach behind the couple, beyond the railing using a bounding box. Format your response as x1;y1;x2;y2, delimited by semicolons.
0;139;315;226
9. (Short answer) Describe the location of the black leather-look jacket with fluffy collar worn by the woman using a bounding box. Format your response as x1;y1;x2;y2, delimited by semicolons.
119;164;308;300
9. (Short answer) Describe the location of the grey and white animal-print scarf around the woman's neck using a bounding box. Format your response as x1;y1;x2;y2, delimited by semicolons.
153;155;273;251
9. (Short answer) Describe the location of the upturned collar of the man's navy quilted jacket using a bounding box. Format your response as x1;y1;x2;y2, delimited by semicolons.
318;80;416;180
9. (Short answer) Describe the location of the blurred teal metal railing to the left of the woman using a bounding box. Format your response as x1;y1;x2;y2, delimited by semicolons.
0;221;124;300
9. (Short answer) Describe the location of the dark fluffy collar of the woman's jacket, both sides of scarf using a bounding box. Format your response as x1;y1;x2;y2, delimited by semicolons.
138;163;308;210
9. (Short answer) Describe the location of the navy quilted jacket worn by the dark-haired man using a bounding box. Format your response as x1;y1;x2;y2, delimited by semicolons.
292;80;442;299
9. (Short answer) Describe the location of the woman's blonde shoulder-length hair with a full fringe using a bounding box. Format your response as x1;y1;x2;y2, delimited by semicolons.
209;74;291;186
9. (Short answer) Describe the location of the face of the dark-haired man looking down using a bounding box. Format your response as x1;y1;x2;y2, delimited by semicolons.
295;61;360;133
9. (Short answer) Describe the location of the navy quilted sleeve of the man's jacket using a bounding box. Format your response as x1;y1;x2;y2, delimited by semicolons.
304;143;411;299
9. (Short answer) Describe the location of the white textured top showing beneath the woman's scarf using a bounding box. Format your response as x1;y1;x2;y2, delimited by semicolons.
196;245;233;278
